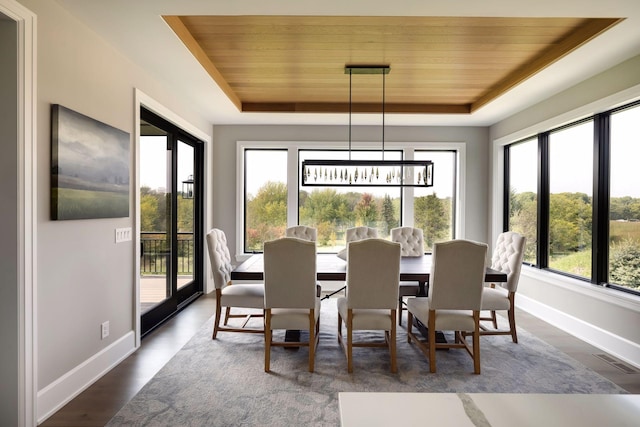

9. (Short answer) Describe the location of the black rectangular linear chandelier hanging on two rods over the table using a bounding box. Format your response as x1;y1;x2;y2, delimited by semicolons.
302;65;433;187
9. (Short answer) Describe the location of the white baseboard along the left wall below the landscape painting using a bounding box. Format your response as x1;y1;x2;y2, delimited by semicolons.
37;331;136;424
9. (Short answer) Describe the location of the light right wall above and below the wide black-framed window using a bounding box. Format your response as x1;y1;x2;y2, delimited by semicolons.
490;56;640;366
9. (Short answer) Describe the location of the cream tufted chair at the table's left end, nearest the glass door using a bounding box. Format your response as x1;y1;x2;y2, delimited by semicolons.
207;228;264;339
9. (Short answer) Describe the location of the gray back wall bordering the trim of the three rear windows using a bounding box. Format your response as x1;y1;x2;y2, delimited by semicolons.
212;125;489;254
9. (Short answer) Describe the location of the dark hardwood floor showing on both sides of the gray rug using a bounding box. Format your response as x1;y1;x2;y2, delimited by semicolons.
41;295;640;427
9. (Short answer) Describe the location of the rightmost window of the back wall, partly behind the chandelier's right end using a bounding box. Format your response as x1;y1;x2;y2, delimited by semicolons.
413;150;457;252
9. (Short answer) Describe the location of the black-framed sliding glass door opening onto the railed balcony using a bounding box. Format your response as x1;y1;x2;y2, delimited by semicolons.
139;109;203;336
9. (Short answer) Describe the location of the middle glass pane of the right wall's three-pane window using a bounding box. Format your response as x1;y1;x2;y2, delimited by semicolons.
548;121;593;277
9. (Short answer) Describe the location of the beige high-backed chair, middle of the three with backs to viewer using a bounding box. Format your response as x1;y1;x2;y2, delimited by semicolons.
337;239;400;372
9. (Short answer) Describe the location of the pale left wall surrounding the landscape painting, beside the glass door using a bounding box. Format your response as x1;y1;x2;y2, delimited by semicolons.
16;0;210;421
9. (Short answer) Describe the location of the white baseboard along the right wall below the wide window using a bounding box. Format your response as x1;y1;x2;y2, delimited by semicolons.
516;294;640;368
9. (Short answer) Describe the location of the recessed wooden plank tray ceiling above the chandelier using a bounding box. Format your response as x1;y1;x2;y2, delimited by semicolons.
164;16;620;114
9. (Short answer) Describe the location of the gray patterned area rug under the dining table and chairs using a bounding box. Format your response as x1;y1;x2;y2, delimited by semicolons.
108;299;625;427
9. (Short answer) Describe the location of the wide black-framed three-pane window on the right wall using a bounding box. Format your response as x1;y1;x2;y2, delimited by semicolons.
504;102;640;295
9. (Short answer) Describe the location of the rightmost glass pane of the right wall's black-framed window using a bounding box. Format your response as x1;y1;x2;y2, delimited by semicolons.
608;105;640;290
